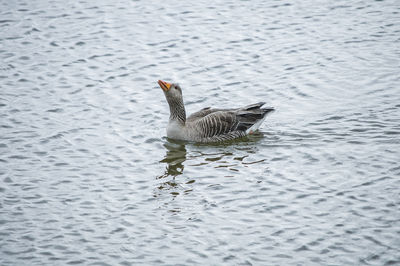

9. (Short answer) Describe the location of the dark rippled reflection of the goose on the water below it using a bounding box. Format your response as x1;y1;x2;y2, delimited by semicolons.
154;133;265;202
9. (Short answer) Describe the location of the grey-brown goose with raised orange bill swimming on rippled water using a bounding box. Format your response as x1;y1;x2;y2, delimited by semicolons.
158;80;274;143
